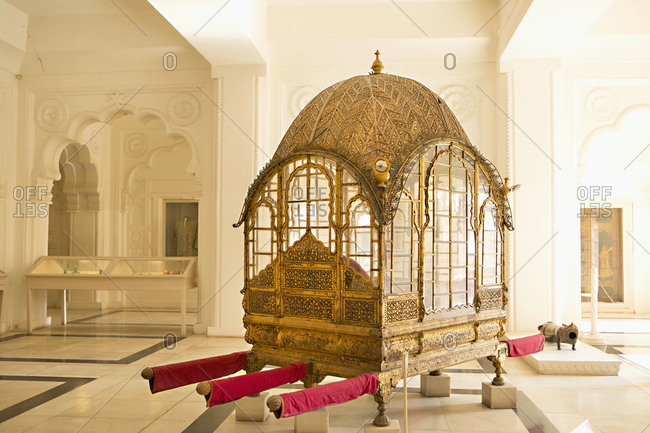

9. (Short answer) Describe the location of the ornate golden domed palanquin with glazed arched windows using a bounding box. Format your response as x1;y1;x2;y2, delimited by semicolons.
235;59;513;403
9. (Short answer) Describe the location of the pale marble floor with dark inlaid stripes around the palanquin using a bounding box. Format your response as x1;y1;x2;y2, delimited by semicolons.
0;310;650;433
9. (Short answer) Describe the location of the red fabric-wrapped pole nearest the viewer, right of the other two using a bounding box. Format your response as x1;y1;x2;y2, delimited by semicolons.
275;373;379;418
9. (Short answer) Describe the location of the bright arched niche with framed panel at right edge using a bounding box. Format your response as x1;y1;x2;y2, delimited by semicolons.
576;105;650;312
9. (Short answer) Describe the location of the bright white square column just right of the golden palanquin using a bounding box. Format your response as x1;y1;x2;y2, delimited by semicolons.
501;59;558;331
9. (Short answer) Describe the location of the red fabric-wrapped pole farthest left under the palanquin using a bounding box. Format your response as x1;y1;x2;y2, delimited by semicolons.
149;352;247;394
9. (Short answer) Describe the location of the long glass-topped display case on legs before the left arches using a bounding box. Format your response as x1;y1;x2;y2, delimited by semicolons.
26;256;197;336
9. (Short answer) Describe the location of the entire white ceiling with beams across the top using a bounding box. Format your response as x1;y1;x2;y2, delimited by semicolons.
0;0;650;74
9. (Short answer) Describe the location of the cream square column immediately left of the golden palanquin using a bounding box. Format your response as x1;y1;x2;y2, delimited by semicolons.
201;65;265;336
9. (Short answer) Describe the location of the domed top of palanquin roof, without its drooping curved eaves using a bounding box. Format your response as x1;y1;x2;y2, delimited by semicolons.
273;74;469;183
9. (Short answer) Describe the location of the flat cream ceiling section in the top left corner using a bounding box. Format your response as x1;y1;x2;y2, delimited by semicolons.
7;0;209;75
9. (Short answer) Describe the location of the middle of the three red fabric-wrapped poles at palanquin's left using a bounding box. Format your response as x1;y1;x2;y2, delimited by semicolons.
205;362;307;407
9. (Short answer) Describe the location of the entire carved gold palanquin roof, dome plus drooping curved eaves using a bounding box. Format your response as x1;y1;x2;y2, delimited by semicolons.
234;73;514;226
